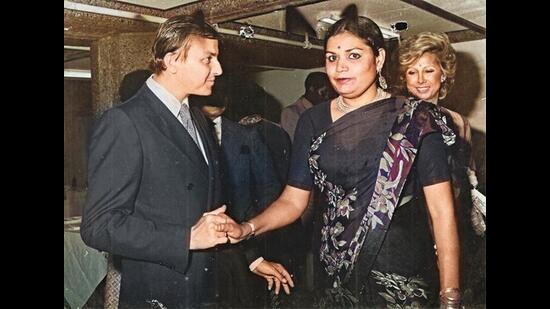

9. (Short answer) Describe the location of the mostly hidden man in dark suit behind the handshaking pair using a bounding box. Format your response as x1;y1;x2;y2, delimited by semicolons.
190;79;282;308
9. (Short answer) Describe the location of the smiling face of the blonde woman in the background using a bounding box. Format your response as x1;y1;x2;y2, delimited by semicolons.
405;52;444;103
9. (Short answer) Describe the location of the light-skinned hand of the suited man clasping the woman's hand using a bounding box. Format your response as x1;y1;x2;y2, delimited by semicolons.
189;205;234;250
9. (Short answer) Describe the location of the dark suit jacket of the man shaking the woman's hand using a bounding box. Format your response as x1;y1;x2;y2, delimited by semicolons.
81;85;221;308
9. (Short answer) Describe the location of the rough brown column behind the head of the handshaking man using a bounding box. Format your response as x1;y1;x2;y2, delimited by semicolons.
90;32;155;116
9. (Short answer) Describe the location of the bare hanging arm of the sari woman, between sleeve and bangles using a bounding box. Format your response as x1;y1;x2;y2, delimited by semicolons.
424;181;460;291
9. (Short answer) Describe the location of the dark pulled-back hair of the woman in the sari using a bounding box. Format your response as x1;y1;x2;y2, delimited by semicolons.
325;4;385;56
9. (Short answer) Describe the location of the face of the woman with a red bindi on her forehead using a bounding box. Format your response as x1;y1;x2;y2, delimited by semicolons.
325;32;386;99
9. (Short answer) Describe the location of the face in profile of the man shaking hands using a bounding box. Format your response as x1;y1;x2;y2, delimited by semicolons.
176;36;223;96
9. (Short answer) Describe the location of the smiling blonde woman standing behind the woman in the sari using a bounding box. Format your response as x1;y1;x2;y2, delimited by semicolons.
398;32;486;302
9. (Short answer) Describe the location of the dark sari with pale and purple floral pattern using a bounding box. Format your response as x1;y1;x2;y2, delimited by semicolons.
309;97;455;307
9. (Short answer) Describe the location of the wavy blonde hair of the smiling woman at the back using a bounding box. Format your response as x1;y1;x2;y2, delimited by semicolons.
398;32;456;99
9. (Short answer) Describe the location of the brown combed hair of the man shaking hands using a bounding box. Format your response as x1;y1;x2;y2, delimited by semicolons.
151;10;220;74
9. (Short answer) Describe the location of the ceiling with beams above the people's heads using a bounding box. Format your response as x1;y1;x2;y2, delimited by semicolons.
64;0;486;68
